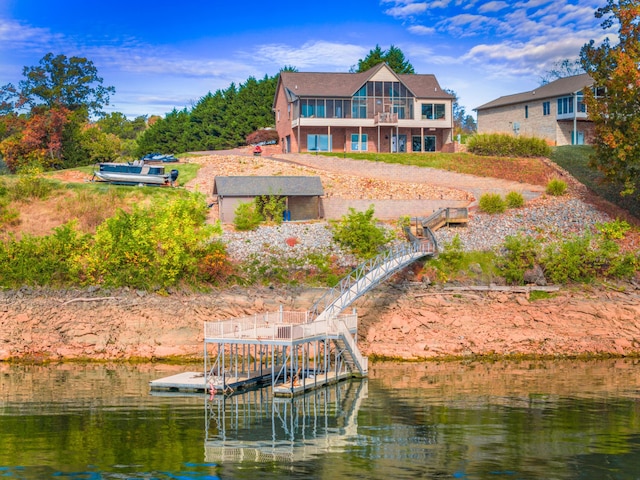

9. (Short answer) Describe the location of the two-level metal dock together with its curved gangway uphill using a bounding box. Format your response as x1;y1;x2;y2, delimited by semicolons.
204;231;438;396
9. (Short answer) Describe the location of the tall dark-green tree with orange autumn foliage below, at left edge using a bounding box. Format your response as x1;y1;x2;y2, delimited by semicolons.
0;53;114;172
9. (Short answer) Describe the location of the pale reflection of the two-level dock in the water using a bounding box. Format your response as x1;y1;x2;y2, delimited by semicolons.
205;379;368;462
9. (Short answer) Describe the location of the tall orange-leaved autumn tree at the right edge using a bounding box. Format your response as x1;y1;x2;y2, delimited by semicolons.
580;0;640;195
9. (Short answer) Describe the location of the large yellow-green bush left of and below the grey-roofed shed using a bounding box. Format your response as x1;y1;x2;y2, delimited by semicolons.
78;195;222;289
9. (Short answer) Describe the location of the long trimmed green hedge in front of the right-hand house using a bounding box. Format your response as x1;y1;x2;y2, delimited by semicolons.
467;133;551;157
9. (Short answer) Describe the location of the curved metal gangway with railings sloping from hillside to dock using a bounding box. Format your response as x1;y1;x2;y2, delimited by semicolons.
309;235;438;321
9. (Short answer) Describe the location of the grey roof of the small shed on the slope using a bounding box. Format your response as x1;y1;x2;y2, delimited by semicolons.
213;176;324;197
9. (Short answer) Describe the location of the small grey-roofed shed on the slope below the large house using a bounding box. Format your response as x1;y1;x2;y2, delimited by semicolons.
213;176;324;223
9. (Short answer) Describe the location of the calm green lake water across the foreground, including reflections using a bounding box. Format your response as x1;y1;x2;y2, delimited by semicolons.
0;359;640;480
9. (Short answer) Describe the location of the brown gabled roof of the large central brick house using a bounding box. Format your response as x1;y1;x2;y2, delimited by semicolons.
276;63;452;105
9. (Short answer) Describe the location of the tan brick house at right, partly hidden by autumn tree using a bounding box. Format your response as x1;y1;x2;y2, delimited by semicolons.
475;73;603;145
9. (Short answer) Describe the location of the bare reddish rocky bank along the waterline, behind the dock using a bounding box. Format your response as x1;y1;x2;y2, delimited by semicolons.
0;280;640;361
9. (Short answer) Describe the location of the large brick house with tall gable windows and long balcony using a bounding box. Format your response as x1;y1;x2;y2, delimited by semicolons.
273;64;454;153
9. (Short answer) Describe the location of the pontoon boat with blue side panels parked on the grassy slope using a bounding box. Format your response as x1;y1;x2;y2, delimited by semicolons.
92;160;178;186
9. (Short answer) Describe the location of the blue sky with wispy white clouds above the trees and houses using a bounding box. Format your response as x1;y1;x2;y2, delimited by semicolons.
0;0;615;118
